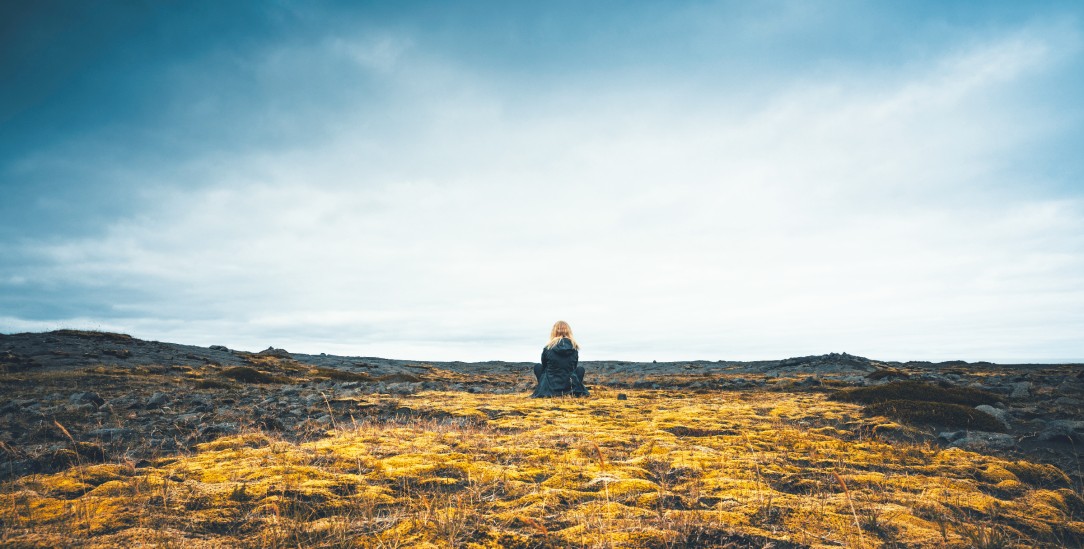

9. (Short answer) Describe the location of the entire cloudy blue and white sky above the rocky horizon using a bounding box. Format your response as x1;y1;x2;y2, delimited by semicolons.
0;0;1084;362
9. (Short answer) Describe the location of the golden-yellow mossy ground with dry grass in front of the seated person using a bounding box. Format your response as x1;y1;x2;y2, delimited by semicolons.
0;387;1084;548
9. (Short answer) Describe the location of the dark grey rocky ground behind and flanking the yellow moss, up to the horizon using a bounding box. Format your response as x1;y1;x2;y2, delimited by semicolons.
0;330;1084;486
